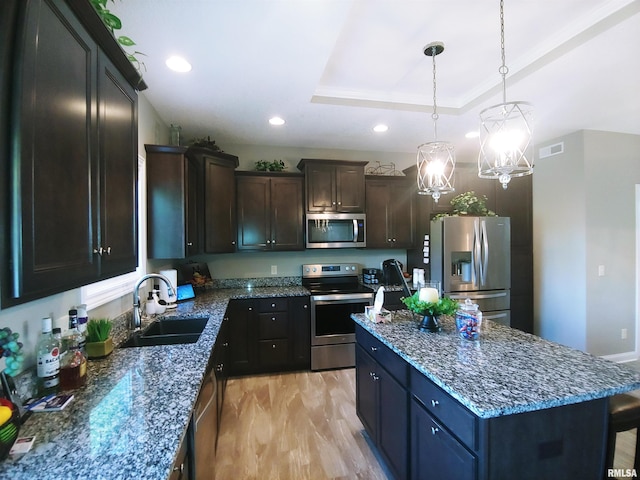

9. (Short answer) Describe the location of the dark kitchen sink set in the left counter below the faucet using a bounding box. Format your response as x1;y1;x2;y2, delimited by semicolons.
120;317;209;348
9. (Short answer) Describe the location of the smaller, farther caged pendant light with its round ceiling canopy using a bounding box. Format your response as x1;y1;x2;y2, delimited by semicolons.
417;42;456;203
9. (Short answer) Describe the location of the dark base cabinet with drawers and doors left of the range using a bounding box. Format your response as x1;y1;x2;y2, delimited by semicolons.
226;296;311;376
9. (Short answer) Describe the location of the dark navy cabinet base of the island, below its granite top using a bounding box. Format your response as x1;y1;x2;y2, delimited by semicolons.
356;325;607;480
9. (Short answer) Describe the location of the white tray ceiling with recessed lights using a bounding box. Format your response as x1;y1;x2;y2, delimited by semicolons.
109;0;640;161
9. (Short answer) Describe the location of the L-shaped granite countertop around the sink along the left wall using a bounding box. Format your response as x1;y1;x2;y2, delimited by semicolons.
0;286;309;480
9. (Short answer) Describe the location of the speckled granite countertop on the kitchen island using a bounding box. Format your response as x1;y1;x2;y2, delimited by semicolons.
352;310;640;418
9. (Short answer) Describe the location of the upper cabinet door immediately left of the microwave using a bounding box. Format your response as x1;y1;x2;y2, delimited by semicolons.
271;177;304;250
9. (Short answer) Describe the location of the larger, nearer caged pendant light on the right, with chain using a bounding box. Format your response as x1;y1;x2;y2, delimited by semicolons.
478;0;533;189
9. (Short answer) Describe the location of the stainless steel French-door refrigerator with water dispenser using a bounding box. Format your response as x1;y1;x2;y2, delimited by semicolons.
429;217;511;326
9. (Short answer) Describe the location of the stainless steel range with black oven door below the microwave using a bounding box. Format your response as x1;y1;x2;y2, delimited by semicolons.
302;263;373;370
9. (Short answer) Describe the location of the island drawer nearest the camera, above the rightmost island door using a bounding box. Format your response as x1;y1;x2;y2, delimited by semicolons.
411;368;478;451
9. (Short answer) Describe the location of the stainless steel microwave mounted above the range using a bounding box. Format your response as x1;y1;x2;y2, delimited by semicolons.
305;213;367;248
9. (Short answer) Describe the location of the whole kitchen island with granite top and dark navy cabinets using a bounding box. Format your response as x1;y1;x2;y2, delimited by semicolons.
352;310;640;480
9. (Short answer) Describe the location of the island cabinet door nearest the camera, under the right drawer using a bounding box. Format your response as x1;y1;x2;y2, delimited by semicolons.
410;400;477;480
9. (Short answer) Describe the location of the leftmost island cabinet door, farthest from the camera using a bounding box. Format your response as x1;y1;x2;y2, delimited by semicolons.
356;344;379;436
